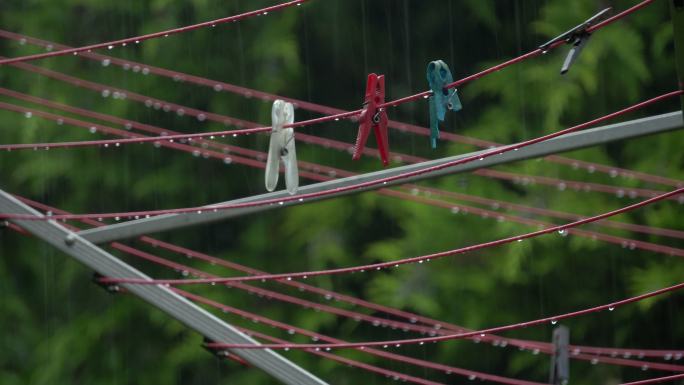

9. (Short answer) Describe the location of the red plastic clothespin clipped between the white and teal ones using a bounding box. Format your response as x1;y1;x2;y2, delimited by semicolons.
352;74;389;166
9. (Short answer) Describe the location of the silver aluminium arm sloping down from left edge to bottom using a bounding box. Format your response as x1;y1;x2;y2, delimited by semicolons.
0;190;326;385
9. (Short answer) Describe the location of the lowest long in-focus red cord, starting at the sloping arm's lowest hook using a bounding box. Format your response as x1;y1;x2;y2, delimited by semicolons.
207;283;684;349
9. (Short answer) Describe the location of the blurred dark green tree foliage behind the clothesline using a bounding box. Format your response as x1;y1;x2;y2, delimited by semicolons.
0;0;684;385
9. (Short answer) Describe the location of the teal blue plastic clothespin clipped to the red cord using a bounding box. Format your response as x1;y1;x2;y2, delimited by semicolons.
427;60;463;148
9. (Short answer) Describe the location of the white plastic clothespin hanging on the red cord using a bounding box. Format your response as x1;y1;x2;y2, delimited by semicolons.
266;100;299;194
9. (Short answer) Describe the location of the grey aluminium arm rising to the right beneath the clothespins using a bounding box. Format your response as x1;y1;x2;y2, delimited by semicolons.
78;111;684;243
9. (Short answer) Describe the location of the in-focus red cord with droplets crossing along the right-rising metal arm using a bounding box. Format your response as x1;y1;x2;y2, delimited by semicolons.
0;90;682;220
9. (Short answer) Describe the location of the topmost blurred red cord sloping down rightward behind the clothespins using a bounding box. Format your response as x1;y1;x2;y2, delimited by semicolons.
0;30;684;187
